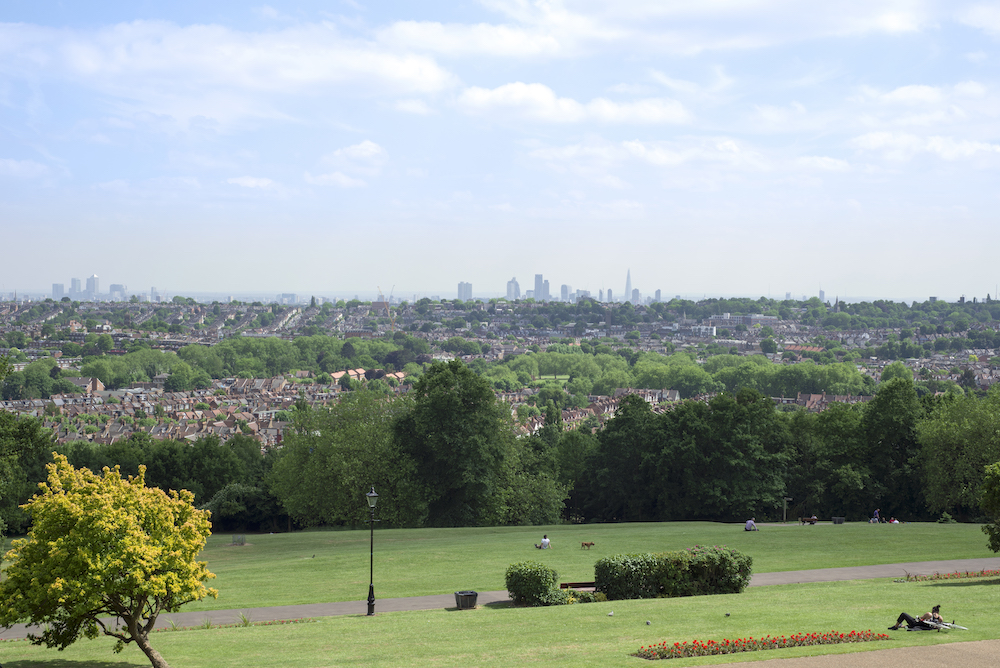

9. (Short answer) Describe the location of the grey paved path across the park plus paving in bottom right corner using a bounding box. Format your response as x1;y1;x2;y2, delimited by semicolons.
0;558;1000;668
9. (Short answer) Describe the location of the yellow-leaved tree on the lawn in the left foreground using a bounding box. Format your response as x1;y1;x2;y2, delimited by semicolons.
0;453;218;668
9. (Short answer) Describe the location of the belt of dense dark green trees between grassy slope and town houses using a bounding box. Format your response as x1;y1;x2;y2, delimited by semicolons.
0;360;1000;533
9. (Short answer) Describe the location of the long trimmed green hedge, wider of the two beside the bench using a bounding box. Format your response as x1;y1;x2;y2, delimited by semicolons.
594;545;753;600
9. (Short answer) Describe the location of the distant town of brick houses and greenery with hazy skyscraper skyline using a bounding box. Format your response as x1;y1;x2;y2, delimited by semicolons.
0;274;1000;448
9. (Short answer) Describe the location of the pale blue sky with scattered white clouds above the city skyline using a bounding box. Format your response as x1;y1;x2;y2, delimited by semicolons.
0;0;1000;302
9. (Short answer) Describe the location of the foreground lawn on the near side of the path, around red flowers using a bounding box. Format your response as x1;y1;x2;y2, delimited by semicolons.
0;579;1000;668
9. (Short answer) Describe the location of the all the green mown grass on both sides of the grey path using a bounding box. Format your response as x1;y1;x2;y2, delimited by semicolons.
0;522;1000;668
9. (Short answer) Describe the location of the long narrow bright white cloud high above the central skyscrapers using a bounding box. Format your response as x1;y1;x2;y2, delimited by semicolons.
458;81;690;123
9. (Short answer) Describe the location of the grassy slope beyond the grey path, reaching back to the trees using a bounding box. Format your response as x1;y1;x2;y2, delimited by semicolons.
184;522;994;611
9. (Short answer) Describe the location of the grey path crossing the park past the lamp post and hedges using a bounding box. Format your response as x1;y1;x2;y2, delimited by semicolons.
0;557;1000;640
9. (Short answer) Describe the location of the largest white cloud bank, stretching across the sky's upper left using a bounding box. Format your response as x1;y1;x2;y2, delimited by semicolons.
0;21;455;125
